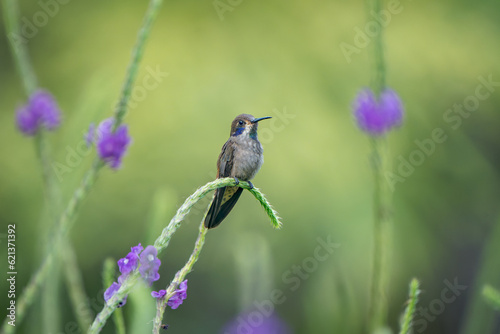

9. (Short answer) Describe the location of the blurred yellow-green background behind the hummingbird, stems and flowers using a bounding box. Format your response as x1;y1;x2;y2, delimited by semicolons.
0;0;500;334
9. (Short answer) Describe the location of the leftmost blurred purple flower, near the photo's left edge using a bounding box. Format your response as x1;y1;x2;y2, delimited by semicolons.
16;90;61;136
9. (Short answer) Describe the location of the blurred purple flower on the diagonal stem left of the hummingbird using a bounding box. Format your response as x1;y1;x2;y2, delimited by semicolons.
97;118;131;169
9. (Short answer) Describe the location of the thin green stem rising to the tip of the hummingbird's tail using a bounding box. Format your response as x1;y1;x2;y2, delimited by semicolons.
153;220;208;334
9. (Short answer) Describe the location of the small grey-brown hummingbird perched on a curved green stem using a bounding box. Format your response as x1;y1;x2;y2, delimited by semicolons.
205;114;271;228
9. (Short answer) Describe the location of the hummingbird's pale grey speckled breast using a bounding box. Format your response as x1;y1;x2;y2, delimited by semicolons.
232;139;264;181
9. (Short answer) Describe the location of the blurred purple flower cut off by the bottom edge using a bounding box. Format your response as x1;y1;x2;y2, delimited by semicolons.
223;310;292;334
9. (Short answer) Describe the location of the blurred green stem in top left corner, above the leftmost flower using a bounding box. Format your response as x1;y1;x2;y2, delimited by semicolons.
2;0;38;97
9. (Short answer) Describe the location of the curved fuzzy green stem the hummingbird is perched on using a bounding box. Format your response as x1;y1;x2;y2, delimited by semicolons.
88;178;281;334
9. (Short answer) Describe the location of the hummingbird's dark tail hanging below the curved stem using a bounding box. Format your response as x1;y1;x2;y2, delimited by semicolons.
205;187;243;228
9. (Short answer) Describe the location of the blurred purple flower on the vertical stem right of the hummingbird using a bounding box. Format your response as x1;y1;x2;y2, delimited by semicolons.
354;89;403;136
